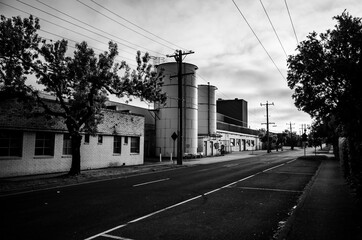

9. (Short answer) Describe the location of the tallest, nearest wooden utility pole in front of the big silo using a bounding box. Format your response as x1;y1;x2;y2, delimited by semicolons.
166;50;194;165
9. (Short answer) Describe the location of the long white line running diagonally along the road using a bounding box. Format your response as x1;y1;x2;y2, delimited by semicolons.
84;161;292;240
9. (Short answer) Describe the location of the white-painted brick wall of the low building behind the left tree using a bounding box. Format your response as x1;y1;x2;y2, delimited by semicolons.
0;113;144;177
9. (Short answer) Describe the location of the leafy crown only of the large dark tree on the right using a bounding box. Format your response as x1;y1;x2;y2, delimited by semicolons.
287;12;362;127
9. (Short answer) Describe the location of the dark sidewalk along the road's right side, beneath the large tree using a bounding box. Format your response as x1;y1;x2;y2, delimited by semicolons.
278;154;362;240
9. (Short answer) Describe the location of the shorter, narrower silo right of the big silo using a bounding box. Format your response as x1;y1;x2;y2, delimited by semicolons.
198;84;217;136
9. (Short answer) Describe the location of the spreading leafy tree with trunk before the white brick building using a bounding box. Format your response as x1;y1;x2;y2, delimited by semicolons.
0;16;166;174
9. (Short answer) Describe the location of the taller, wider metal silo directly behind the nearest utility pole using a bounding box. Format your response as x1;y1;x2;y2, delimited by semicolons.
156;62;198;157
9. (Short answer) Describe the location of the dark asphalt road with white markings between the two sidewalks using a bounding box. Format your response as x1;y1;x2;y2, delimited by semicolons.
0;152;320;240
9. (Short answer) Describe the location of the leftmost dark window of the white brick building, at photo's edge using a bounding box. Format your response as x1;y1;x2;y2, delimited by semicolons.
0;130;23;157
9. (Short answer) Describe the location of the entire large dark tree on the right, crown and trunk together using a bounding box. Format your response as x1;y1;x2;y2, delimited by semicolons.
287;11;362;190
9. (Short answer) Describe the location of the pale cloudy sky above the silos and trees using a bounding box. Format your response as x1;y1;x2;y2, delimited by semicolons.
0;0;362;134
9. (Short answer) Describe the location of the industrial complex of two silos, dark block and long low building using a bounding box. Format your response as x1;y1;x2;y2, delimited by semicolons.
107;62;261;157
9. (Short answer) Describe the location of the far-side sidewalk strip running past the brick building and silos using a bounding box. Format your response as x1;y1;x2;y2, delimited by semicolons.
0;151;266;196
